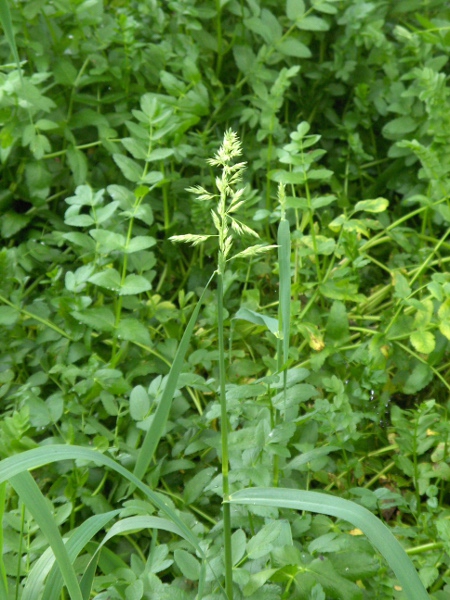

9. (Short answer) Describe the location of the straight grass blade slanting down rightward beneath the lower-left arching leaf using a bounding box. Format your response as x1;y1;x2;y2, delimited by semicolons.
9;471;83;600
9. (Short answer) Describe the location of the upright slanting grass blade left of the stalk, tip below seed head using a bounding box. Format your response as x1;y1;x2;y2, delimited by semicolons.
133;274;214;480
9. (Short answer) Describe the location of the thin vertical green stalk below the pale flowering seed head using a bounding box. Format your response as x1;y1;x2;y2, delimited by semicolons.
217;260;233;600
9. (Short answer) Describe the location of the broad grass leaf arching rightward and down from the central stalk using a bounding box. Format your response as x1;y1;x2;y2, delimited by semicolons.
229;488;430;600
